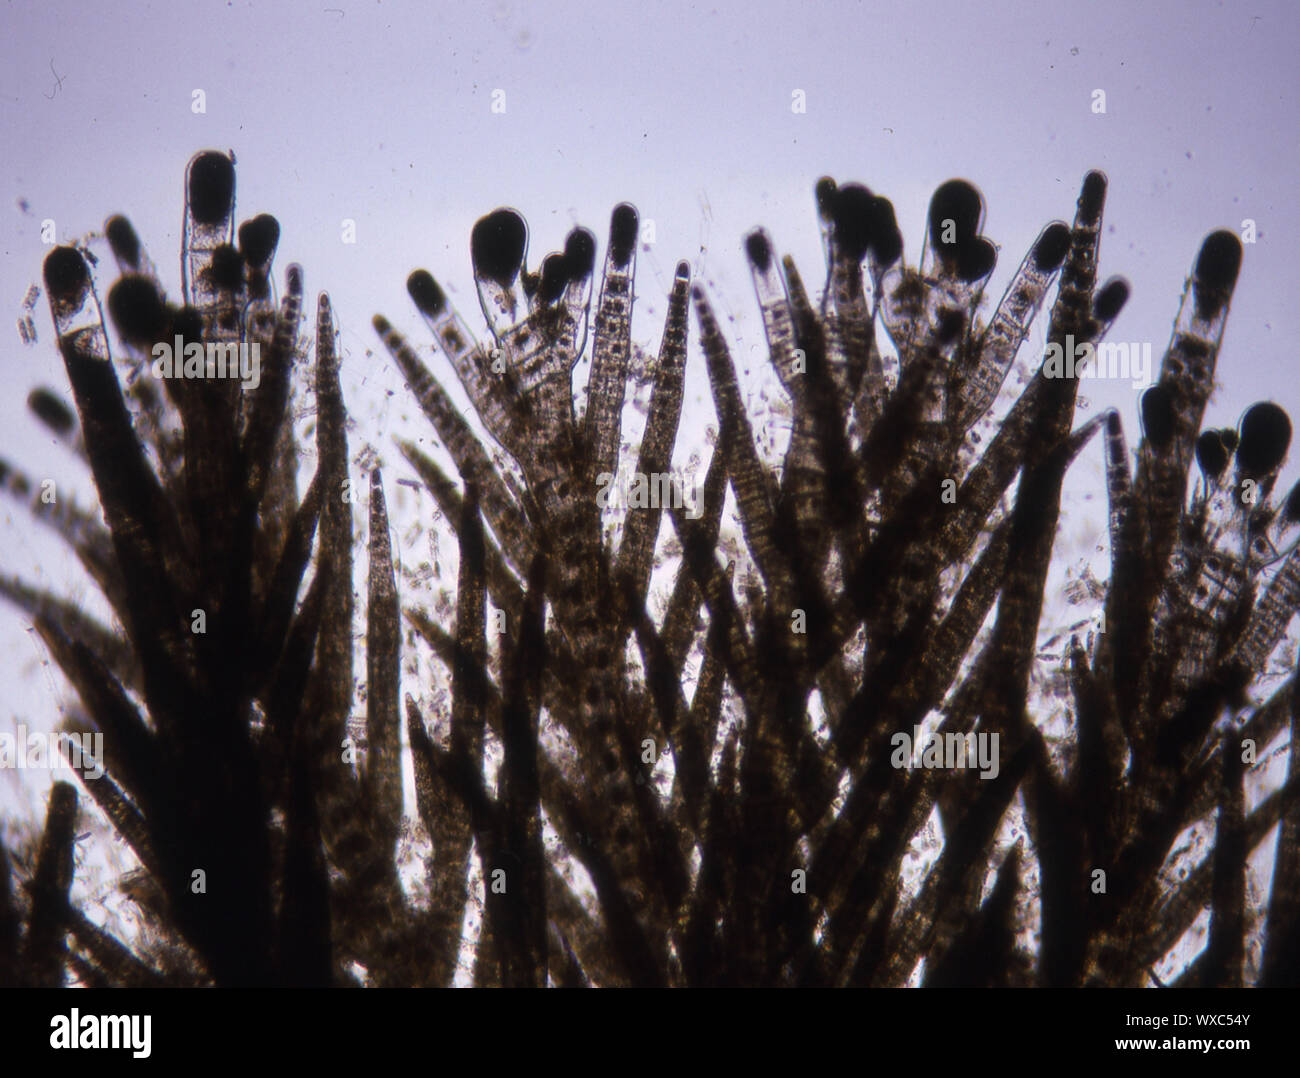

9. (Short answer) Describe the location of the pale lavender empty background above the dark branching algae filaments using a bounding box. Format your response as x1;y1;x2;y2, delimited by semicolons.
0;0;1300;957
